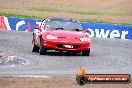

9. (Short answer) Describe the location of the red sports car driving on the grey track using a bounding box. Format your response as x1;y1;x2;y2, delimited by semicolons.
32;18;91;56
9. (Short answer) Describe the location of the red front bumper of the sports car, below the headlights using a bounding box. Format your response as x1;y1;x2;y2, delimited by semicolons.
44;39;90;51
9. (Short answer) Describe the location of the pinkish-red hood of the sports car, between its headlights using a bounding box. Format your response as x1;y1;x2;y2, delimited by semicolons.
47;30;86;38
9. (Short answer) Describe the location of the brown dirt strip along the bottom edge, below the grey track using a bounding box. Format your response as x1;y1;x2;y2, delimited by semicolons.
0;76;132;88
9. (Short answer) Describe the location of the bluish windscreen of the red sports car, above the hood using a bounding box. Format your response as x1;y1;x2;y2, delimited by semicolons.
45;19;82;30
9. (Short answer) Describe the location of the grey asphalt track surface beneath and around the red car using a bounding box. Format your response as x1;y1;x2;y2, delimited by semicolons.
0;31;132;76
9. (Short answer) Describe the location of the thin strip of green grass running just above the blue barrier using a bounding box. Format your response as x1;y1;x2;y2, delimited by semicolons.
0;13;132;25
